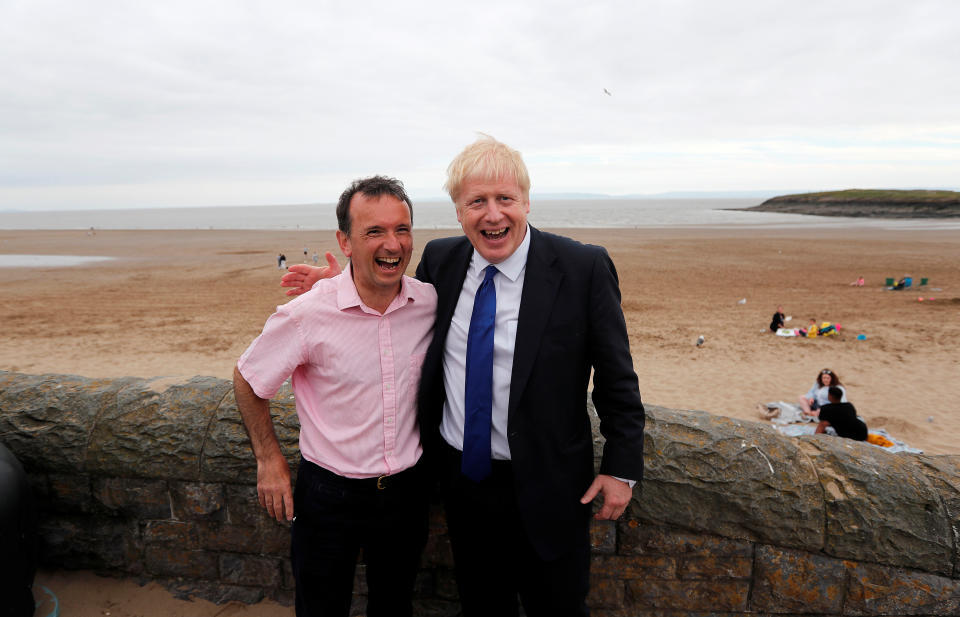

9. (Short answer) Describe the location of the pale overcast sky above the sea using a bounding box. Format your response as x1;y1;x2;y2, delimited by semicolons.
0;0;960;210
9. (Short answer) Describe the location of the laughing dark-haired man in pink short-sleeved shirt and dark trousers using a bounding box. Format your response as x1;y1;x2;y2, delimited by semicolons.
234;176;437;617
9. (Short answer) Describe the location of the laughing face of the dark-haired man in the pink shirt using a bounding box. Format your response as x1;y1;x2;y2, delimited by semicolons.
337;193;413;312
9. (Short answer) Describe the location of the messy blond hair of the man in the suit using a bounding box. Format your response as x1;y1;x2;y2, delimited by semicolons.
443;133;530;203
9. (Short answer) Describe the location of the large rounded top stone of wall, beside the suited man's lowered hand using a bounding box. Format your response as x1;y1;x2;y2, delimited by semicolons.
628;405;824;550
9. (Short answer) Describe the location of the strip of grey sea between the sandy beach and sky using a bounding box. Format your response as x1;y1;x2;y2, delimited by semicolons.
0;198;960;230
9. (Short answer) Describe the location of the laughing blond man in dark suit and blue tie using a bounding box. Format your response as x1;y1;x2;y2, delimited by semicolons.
282;136;644;617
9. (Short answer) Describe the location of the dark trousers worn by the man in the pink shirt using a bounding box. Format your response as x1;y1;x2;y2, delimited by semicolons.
290;459;428;617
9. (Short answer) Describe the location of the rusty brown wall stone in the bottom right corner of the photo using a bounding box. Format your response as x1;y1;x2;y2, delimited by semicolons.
844;562;960;616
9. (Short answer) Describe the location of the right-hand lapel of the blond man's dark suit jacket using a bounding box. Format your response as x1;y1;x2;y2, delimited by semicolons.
508;227;563;415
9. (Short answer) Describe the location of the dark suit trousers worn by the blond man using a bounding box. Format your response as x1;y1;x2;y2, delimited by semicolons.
438;444;590;617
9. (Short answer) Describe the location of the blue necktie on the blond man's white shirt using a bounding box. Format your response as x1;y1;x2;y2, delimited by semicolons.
460;265;497;482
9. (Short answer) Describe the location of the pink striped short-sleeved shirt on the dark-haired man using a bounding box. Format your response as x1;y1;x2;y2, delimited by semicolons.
238;266;437;478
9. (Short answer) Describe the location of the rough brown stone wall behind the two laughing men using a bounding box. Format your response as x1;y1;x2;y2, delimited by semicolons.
0;371;960;617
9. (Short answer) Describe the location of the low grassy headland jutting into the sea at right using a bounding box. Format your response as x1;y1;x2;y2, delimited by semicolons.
739;189;960;219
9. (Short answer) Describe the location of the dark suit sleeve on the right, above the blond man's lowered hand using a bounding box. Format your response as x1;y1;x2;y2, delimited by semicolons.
589;248;645;481
